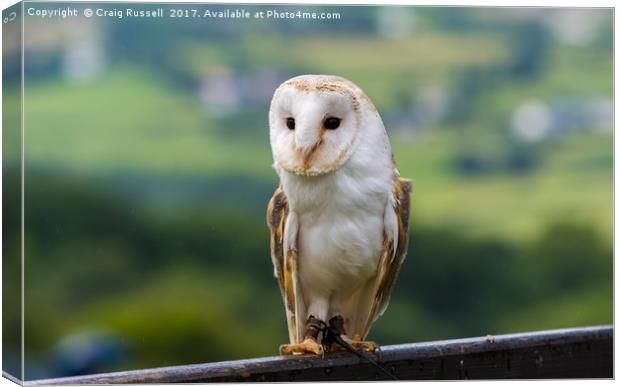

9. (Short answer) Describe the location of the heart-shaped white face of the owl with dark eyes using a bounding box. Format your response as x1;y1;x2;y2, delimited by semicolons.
269;76;360;176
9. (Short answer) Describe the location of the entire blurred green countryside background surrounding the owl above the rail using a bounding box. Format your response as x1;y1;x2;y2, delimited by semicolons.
4;6;613;378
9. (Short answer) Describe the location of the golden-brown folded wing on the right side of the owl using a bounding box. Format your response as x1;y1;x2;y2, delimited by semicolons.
361;177;411;337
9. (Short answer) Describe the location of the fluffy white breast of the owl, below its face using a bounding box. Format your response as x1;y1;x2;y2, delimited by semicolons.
279;116;394;304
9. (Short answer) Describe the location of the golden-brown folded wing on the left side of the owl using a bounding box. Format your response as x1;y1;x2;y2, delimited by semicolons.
267;187;299;343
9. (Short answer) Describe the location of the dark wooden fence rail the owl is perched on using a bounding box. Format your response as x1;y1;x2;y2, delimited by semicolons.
26;326;613;386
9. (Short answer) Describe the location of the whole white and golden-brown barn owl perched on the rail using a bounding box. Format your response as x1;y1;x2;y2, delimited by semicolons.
267;75;411;355
